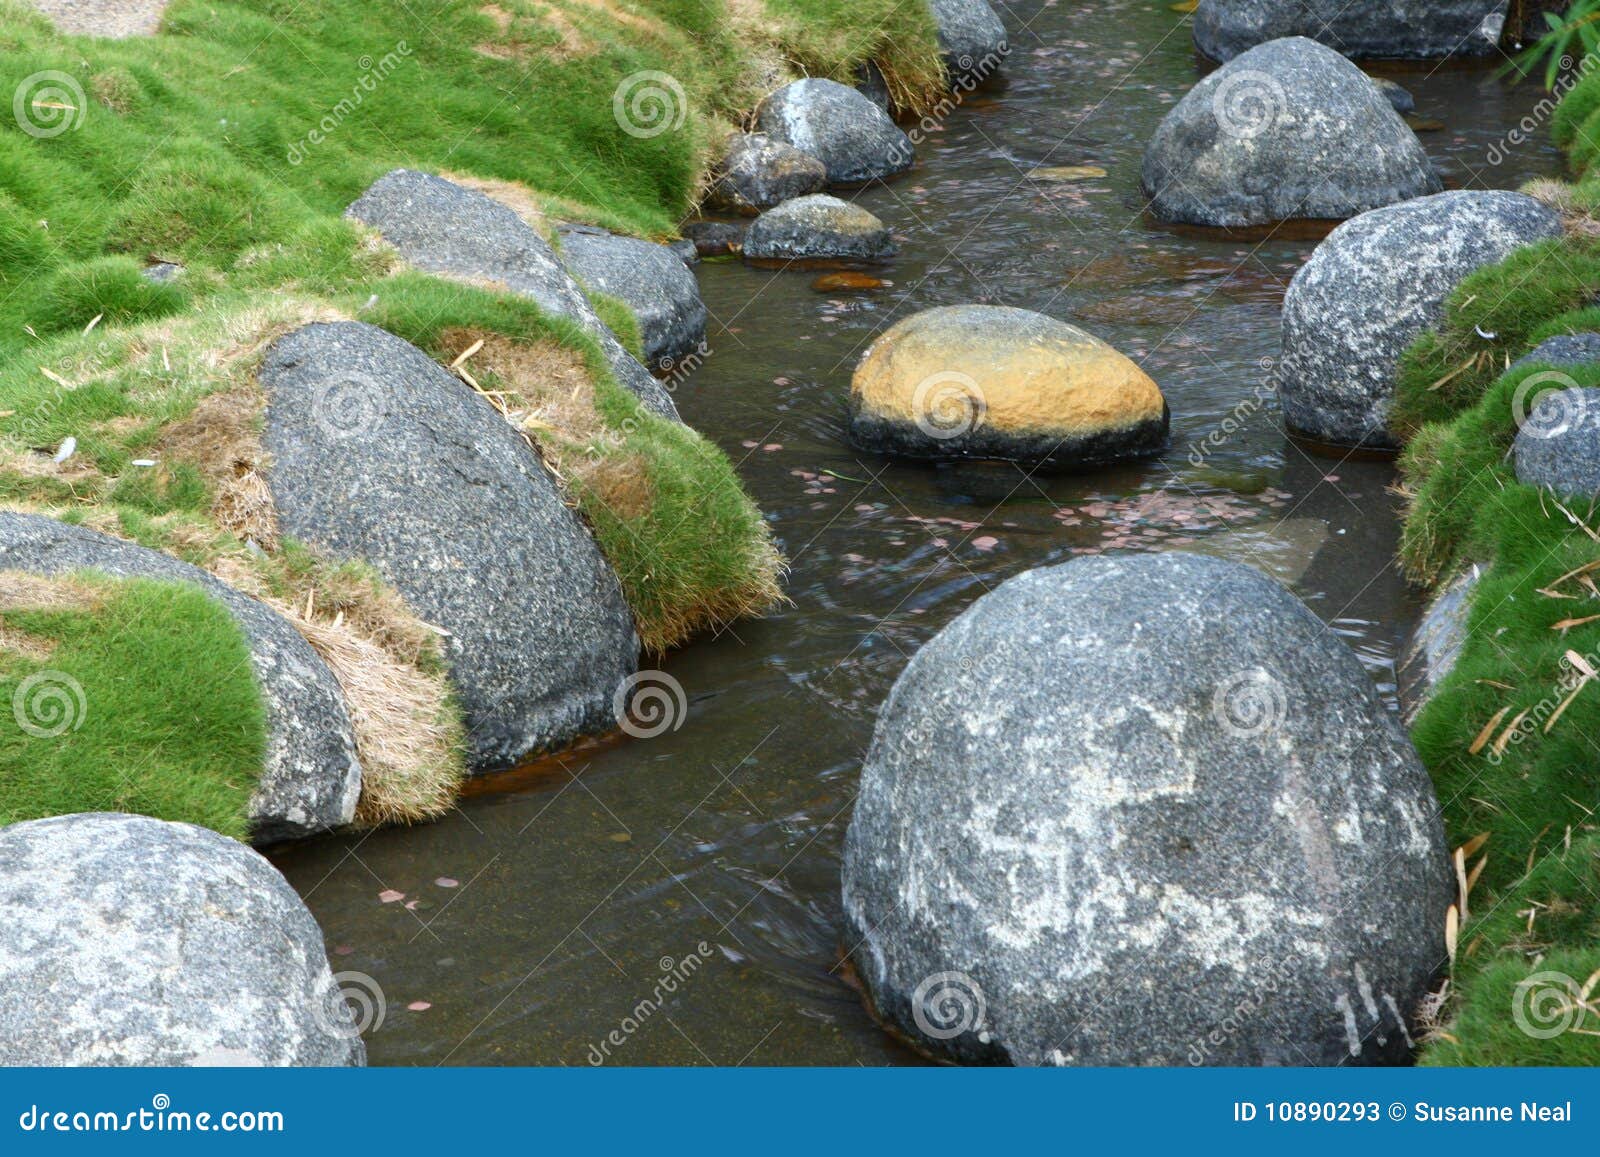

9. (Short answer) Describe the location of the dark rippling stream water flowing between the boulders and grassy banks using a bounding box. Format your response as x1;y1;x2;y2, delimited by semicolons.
275;0;1558;1064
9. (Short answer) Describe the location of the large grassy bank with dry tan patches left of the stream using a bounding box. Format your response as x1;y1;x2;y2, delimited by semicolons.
0;0;941;834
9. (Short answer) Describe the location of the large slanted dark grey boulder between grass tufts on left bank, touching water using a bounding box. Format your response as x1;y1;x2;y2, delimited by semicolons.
258;322;638;773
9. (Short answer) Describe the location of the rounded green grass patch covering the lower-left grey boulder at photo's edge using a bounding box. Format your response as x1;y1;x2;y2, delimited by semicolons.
0;574;267;839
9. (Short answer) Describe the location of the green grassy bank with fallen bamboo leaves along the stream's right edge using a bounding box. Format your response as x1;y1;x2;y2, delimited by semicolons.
1394;82;1600;1066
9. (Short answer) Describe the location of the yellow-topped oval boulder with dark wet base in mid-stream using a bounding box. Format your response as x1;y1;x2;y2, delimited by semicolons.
850;306;1168;469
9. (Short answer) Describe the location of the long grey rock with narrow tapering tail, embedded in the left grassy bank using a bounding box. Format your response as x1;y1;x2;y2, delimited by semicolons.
346;168;678;419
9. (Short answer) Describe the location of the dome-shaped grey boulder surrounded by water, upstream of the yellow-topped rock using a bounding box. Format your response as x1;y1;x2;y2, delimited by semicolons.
1141;37;1440;229
